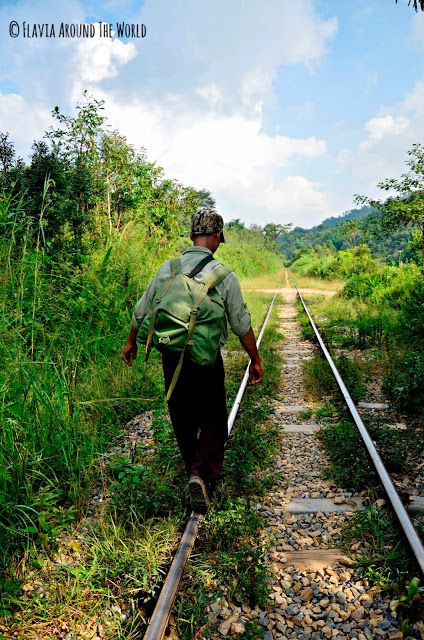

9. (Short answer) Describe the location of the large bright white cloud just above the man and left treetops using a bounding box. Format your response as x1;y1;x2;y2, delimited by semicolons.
94;94;328;223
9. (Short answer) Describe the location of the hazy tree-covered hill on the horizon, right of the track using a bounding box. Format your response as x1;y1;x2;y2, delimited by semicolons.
279;207;414;263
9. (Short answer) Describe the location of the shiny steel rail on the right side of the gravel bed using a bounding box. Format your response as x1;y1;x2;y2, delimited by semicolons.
296;287;424;573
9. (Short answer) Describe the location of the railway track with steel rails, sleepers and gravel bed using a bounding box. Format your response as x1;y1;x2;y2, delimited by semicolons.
144;288;424;640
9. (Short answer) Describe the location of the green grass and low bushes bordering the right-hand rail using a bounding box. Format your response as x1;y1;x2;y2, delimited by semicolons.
286;250;424;587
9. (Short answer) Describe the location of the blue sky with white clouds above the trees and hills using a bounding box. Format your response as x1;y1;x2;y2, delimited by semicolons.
0;0;424;227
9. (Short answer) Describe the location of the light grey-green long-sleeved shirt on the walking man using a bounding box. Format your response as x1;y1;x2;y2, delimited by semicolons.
131;247;251;346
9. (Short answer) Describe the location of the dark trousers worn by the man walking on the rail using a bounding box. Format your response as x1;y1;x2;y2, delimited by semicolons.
162;352;228;489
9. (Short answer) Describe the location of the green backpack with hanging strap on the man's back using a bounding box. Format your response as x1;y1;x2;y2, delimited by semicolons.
138;255;231;400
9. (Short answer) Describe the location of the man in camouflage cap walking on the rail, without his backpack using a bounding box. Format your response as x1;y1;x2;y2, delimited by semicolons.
122;209;263;513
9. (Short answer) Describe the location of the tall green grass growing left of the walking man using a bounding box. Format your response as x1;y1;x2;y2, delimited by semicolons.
0;197;179;562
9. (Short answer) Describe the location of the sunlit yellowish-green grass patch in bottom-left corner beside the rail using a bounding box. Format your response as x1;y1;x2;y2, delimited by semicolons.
1;518;179;639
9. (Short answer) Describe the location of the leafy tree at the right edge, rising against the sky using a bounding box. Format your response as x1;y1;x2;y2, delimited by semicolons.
355;144;424;272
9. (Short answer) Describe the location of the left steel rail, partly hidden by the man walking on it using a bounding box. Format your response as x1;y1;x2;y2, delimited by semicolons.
144;293;277;640
